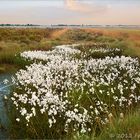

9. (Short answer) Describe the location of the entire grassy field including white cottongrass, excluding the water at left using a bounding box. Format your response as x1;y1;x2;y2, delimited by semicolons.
0;28;140;140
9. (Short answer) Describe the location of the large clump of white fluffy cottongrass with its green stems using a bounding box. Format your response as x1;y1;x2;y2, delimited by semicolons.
3;45;140;139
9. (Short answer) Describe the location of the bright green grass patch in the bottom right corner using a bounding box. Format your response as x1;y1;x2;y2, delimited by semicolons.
97;110;140;140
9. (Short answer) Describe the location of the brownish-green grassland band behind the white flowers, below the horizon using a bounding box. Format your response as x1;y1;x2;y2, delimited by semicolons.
0;28;140;70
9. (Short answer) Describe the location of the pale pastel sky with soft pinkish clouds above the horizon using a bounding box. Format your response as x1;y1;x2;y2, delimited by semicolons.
0;0;140;25
